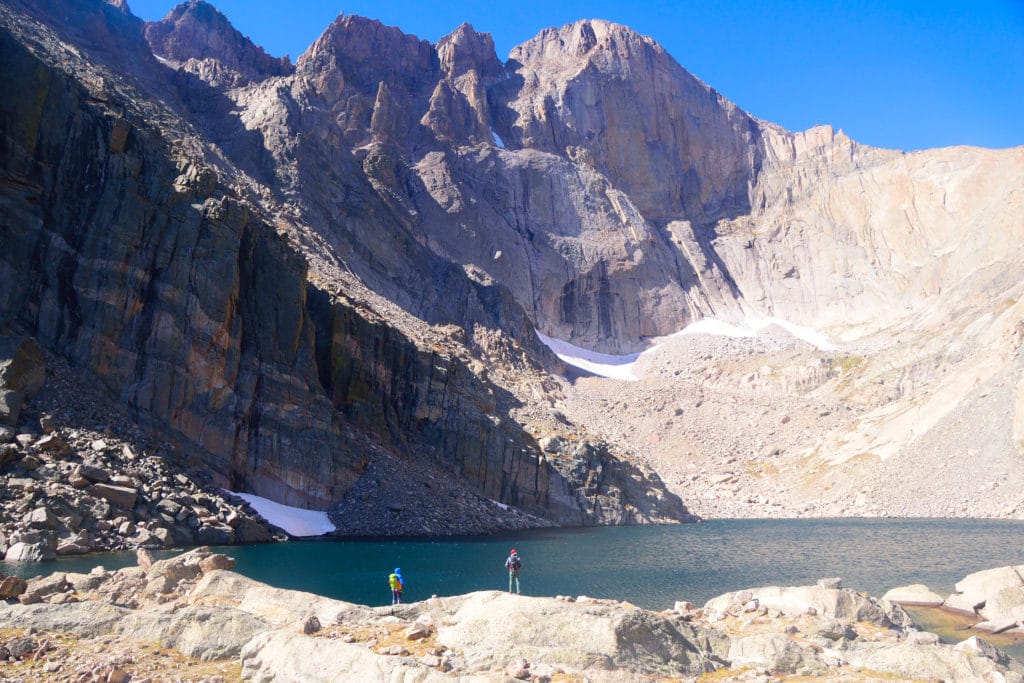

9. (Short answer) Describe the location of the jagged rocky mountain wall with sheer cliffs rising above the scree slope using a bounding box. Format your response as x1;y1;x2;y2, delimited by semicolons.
0;0;1024;533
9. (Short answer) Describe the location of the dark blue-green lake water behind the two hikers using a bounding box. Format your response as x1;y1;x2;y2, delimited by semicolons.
0;519;1024;609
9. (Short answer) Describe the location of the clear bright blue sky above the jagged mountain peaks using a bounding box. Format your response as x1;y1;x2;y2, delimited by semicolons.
129;0;1024;150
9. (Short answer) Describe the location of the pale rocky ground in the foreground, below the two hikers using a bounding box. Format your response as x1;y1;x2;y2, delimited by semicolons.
0;548;1024;683
